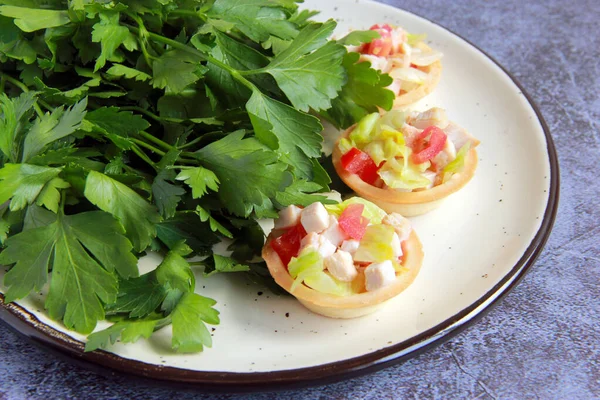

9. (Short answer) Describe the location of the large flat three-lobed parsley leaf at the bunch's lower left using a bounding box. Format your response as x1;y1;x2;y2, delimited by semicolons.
0;211;137;333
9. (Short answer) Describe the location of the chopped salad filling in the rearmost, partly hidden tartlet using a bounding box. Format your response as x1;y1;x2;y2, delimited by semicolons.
349;24;443;96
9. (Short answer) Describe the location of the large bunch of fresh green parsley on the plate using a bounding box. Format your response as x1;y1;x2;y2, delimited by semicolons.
0;0;393;352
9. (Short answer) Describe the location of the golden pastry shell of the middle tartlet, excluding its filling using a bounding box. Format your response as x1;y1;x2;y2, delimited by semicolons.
332;108;479;217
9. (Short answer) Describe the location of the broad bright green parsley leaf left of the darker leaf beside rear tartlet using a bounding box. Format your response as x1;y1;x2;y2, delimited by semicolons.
264;21;346;111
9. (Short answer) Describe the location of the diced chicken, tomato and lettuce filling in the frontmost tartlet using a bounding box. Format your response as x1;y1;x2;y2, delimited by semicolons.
270;197;412;296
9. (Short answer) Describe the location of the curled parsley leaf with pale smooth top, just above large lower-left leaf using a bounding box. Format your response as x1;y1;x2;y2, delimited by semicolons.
84;171;161;251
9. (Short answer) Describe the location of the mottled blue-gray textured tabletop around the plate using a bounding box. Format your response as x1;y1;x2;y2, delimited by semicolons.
0;0;600;400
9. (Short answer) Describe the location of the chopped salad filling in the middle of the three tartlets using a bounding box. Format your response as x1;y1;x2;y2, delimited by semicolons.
338;108;479;192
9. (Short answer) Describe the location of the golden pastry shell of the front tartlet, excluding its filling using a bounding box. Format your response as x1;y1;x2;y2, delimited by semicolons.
262;199;424;318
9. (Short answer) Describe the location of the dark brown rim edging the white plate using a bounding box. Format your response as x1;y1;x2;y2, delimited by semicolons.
0;3;560;392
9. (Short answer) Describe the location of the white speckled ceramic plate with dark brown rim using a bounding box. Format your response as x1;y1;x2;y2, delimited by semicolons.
0;0;558;390
